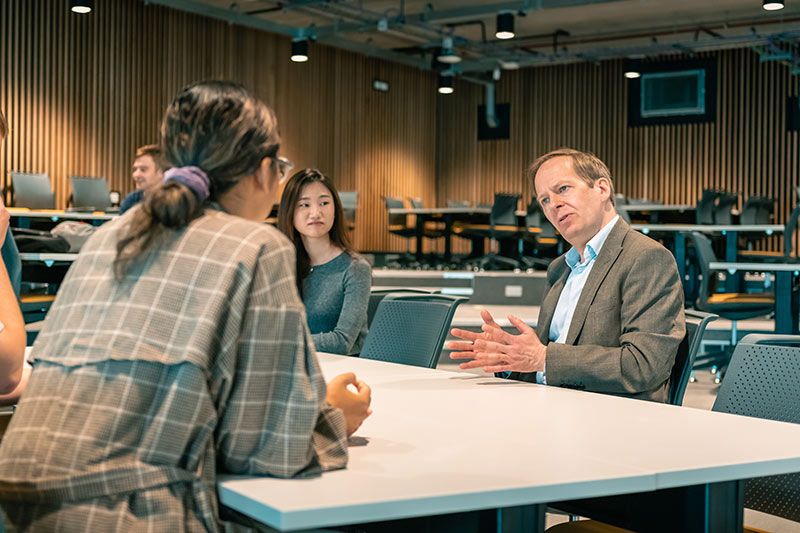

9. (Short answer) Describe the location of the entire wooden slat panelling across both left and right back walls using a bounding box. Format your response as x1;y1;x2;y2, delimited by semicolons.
0;0;800;254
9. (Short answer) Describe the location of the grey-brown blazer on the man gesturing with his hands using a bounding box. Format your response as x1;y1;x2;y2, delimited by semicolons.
512;219;686;402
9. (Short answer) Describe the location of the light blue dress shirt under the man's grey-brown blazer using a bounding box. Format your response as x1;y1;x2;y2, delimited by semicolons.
536;215;619;385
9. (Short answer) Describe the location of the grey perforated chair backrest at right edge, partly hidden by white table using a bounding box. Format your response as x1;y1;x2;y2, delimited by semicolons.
713;334;800;522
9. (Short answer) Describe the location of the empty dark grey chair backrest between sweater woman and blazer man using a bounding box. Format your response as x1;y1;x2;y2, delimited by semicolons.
360;294;467;368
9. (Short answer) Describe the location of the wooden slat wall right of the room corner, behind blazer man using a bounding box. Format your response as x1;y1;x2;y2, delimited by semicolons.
437;49;800;251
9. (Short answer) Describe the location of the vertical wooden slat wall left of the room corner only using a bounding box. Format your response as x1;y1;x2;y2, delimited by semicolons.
0;0;436;250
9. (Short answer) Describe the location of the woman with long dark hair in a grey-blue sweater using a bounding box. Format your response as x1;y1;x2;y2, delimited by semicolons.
278;168;372;355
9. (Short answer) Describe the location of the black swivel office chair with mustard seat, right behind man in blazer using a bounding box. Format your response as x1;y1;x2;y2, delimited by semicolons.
690;231;775;383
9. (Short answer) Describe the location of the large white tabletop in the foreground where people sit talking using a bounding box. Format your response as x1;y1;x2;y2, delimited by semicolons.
219;354;800;530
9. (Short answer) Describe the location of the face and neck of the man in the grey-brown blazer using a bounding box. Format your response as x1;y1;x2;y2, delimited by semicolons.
534;156;614;254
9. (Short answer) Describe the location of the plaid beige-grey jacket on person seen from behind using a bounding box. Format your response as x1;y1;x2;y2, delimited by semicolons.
0;210;347;531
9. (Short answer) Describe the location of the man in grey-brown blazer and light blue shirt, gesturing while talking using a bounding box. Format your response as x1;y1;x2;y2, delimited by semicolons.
450;149;686;402
